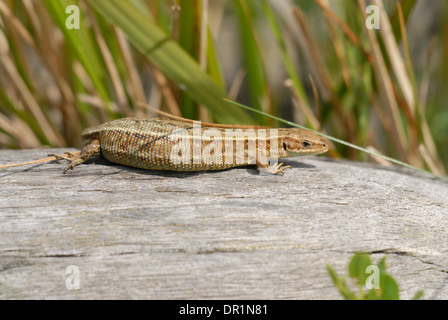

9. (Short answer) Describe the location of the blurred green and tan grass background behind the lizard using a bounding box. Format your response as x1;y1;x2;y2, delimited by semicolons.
0;0;448;175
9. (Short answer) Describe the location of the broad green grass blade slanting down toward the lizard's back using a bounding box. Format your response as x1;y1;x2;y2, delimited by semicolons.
92;0;254;124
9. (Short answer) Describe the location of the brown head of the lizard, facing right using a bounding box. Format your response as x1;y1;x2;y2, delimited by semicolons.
279;128;329;157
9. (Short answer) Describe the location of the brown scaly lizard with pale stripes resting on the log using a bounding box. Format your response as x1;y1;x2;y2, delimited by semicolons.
49;118;329;175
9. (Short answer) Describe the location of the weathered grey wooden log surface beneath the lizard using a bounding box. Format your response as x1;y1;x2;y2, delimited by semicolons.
0;149;448;299
